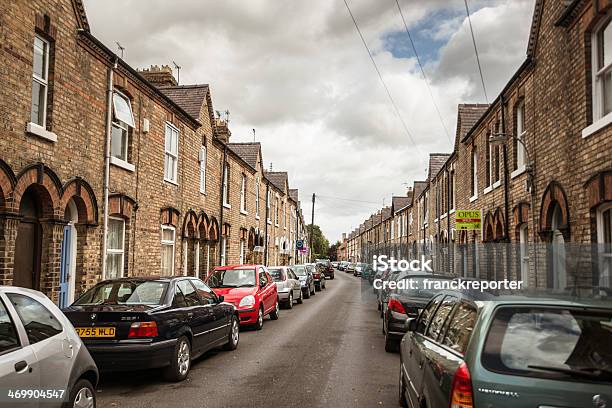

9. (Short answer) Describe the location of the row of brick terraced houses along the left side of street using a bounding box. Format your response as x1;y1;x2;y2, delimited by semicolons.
0;0;307;306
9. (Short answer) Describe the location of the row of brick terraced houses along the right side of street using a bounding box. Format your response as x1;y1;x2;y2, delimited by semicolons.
347;0;612;293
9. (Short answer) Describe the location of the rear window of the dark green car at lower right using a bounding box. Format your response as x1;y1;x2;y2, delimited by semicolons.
482;307;612;382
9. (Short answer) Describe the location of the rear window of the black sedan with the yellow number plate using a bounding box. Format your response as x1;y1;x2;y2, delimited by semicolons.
74;281;168;306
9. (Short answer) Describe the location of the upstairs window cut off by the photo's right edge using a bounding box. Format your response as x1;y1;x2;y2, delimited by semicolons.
592;20;612;122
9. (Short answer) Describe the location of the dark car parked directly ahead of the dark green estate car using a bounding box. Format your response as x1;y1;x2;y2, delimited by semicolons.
383;272;451;352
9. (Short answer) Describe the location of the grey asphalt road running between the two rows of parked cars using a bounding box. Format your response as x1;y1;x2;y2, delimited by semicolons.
97;271;399;408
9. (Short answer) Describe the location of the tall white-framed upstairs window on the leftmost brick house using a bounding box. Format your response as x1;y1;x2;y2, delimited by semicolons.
30;35;49;128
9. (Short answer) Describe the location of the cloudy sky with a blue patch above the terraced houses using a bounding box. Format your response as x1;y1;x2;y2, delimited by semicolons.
85;0;534;242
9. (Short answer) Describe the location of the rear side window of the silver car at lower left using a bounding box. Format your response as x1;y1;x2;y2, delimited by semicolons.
7;293;63;344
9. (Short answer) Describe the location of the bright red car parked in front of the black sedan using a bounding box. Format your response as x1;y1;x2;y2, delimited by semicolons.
206;265;279;330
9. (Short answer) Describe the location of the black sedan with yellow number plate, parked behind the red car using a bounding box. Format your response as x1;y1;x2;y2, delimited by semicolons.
63;276;239;381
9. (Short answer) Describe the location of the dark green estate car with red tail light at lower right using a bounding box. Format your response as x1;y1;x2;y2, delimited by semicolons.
399;291;612;408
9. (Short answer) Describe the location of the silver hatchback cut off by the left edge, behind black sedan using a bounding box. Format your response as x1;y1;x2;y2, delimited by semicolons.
0;286;98;408
